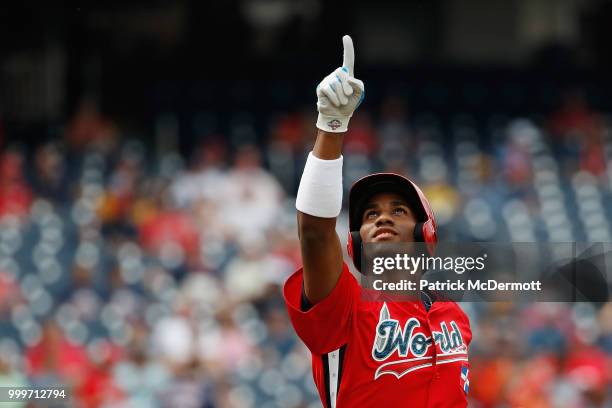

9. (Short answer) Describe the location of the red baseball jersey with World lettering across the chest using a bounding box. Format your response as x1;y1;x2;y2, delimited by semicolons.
283;264;472;408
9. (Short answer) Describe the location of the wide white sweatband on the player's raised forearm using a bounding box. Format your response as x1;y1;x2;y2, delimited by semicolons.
295;152;342;218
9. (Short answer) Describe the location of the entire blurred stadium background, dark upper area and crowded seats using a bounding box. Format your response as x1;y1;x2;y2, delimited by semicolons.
0;0;612;408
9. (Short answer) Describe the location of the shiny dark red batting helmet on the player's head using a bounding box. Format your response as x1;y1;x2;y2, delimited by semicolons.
347;173;438;272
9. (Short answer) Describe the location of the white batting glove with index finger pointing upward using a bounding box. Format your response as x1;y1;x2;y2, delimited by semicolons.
317;35;365;133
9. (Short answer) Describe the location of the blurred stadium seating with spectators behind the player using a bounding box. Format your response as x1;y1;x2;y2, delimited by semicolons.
0;91;612;408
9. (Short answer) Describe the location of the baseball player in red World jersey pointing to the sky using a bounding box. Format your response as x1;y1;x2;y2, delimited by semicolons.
283;36;472;408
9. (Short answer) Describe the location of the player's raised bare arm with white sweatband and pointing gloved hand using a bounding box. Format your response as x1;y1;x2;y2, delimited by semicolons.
296;35;365;303
